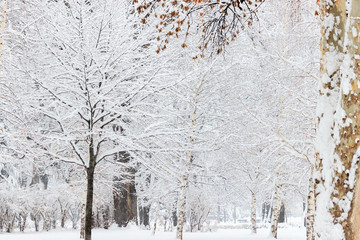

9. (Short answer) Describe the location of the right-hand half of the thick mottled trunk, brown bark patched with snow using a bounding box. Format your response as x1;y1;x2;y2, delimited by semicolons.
331;0;360;240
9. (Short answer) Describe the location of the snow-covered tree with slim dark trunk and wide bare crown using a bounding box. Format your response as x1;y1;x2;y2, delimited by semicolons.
7;0;165;240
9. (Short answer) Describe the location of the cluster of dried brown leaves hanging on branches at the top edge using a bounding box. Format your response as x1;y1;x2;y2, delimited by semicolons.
133;0;264;54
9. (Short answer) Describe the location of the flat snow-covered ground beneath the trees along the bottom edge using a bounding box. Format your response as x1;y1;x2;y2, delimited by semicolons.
0;228;305;240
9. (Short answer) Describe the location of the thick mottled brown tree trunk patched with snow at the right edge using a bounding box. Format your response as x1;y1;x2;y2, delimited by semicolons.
315;0;360;240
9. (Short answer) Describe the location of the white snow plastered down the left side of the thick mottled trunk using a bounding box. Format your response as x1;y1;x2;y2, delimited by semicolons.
315;2;343;240
